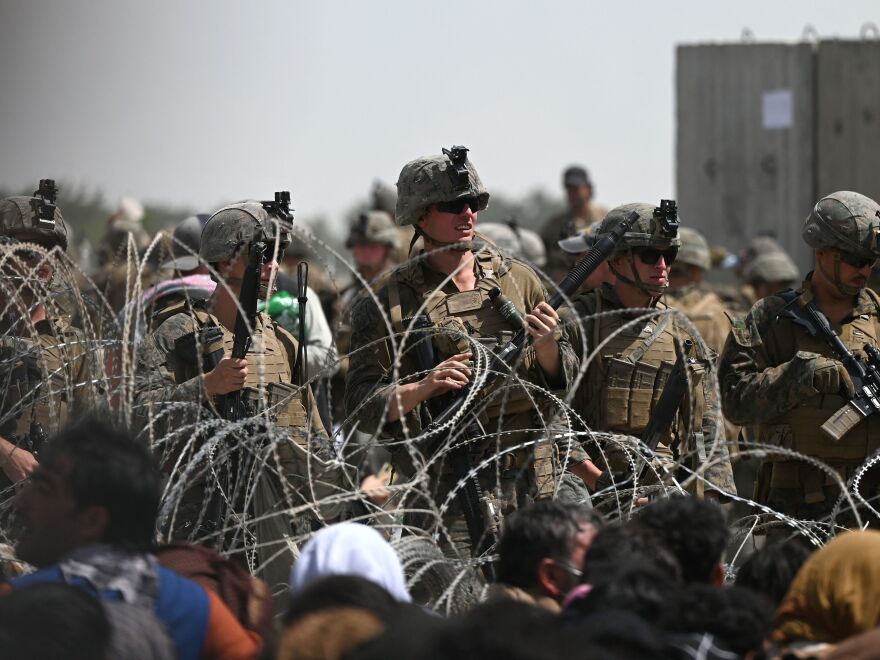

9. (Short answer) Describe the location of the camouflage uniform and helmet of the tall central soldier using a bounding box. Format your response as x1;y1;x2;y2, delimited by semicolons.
345;148;576;548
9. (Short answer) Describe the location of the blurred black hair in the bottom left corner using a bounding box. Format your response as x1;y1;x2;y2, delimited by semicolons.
0;582;111;660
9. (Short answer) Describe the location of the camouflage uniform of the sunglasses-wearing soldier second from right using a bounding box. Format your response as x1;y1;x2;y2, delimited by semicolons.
568;204;735;493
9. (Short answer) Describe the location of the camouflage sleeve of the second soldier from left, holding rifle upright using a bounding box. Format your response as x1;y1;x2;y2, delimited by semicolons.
134;314;205;414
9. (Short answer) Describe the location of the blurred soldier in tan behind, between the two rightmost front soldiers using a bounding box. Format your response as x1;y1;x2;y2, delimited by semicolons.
666;227;730;354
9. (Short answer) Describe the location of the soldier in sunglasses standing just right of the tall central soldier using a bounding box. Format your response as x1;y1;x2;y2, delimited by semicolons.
569;204;735;497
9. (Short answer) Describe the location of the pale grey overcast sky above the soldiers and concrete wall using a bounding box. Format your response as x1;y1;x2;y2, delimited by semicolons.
0;0;880;229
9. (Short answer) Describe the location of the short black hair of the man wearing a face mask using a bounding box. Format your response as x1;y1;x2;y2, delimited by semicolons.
497;500;602;589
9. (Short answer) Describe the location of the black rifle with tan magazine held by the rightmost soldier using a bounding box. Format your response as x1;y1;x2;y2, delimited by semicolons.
781;291;880;442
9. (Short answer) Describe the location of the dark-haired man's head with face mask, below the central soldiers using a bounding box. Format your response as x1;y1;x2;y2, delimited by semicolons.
498;501;601;600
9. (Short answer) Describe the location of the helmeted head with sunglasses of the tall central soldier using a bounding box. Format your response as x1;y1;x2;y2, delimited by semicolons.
395;147;489;250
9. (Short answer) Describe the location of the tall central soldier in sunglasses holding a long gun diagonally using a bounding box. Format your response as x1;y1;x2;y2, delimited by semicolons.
345;147;576;549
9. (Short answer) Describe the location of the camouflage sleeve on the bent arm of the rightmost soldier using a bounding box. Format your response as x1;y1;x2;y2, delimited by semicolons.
718;299;817;424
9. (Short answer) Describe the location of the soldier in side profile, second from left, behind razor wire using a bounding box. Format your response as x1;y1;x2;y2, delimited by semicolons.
135;201;343;588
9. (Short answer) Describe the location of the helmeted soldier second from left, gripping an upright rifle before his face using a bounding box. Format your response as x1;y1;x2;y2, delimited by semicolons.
135;201;342;589
